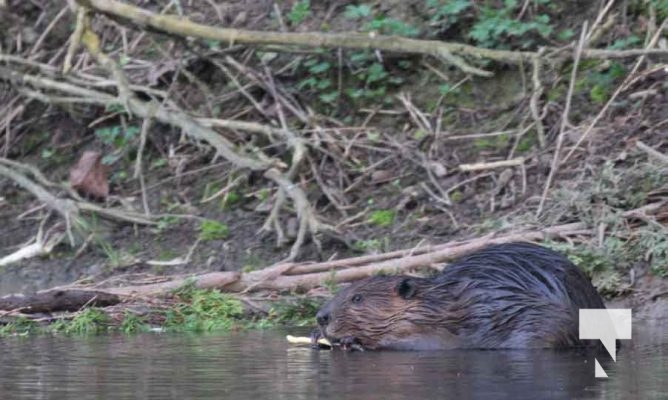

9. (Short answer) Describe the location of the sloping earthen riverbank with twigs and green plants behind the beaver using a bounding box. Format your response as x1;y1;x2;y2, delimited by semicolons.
0;0;668;334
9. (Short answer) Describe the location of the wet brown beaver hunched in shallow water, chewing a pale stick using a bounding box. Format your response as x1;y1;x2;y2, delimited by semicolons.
311;243;605;350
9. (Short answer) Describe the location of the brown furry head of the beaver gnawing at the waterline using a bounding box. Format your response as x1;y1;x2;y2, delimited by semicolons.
316;276;454;349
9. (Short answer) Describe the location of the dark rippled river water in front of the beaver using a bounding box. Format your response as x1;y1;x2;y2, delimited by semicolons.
0;324;668;400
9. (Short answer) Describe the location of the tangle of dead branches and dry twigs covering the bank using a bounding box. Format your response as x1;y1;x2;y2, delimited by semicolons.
0;0;668;324
